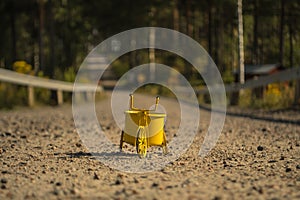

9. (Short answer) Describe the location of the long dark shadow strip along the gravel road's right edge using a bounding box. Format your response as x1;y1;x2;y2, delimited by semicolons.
199;105;300;125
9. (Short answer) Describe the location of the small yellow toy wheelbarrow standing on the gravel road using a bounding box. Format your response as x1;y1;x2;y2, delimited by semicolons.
120;94;167;158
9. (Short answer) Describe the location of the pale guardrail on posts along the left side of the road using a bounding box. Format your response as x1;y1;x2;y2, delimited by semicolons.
0;68;103;106
